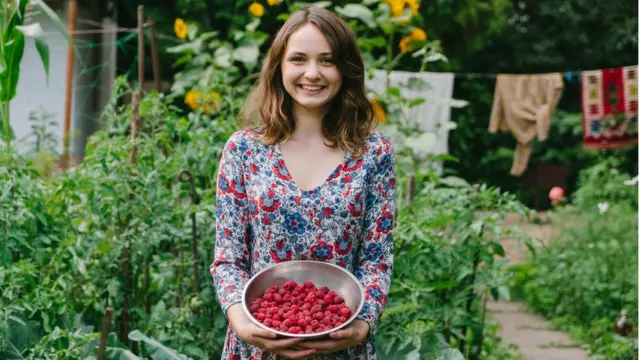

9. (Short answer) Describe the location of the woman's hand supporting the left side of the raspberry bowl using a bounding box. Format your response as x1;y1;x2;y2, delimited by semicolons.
227;304;316;359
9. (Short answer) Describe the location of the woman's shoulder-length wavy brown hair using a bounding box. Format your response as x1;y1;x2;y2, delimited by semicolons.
240;7;375;156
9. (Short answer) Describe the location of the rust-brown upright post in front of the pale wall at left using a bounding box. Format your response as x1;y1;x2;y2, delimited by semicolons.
61;0;78;170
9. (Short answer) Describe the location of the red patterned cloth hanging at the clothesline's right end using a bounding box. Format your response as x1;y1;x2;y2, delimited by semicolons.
581;66;638;149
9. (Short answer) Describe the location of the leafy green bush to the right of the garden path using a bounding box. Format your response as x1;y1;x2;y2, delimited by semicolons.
513;178;638;360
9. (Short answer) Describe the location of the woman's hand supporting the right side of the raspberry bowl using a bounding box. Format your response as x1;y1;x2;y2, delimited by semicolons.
294;319;370;354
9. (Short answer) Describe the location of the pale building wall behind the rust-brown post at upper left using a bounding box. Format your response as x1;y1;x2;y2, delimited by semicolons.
10;5;116;158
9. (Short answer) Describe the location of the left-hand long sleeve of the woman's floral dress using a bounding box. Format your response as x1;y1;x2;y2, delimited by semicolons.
210;133;250;315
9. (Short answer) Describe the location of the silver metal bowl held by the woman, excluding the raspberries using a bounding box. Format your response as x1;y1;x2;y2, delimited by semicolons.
242;260;364;339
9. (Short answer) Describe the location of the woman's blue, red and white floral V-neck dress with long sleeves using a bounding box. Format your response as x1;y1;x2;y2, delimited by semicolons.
211;129;396;360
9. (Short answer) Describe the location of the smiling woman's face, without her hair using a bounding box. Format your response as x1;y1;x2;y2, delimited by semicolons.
281;24;342;111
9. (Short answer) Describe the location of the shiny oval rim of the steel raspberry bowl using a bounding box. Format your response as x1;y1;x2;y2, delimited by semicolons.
242;260;365;338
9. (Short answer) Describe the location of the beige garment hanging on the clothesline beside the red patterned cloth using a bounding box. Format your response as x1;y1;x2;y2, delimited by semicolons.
489;73;564;176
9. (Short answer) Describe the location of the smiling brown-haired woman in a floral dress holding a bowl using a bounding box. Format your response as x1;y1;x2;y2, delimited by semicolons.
211;7;396;360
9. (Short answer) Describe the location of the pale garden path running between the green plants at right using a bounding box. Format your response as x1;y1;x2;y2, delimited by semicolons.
487;214;591;360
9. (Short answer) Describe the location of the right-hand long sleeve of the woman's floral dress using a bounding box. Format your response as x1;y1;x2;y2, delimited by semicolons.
355;136;396;333
